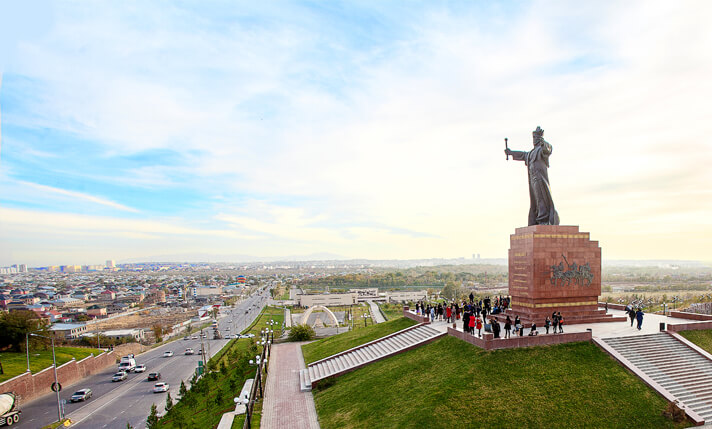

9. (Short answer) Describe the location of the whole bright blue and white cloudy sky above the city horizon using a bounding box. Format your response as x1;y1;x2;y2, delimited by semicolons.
0;1;712;266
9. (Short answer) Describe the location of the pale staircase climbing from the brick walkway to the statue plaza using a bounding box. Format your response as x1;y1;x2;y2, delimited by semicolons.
299;323;447;391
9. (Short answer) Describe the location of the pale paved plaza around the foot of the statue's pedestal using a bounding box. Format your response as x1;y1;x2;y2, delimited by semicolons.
418;309;695;338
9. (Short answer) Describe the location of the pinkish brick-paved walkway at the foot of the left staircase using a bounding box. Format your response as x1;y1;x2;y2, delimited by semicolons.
260;343;319;429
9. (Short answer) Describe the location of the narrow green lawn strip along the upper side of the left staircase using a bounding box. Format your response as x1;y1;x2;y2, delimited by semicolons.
302;317;415;364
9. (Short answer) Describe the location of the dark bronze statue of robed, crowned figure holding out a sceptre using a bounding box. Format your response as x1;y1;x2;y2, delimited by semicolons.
504;127;559;225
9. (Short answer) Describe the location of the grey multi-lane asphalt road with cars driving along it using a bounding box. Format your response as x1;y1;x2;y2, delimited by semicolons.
18;289;269;429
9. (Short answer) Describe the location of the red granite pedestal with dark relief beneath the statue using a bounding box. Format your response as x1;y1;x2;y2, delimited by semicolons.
498;225;624;327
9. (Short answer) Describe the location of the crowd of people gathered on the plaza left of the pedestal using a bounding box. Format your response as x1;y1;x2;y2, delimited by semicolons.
415;294;564;338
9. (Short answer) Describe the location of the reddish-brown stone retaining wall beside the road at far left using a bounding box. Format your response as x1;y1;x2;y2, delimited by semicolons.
0;352;116;403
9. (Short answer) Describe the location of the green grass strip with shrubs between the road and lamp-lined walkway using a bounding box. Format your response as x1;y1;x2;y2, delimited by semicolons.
159;307;284;429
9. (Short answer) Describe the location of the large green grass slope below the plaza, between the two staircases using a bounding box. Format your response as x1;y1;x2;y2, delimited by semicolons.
314;337;684;429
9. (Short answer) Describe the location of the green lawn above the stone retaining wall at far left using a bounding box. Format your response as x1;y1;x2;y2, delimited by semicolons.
0;347;102;382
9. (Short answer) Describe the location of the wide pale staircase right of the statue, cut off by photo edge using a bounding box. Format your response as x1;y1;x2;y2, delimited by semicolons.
603;333;712;422
